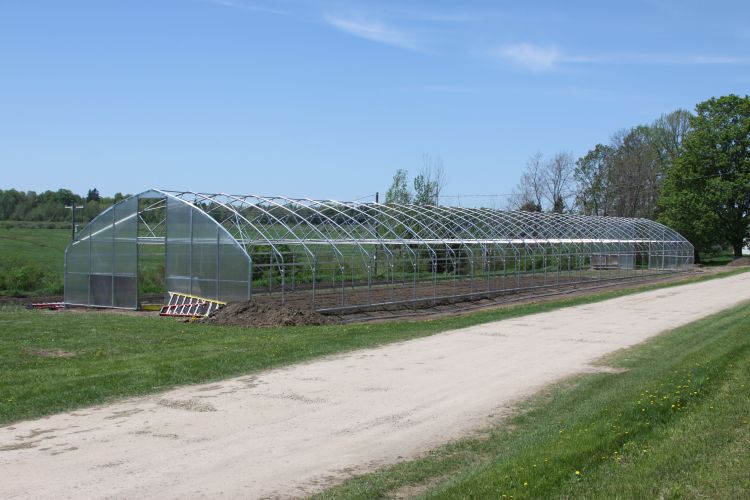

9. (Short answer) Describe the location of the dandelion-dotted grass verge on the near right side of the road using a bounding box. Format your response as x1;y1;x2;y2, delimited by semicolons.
317;298;750;499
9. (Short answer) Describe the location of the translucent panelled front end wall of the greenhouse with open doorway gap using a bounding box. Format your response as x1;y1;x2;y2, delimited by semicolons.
65;191;251;309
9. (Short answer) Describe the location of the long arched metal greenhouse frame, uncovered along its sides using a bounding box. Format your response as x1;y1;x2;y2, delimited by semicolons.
65;189;693;312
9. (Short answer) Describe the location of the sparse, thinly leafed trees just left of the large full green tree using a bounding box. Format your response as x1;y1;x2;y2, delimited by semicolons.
508;109;692;219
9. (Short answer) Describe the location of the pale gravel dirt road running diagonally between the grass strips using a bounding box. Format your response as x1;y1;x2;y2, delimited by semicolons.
0;273;750;498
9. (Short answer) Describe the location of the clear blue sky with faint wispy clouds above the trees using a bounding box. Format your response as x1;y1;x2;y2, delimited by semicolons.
0;0;750;205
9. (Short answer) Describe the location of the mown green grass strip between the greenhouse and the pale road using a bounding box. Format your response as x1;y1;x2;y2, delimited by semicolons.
0;269;745;424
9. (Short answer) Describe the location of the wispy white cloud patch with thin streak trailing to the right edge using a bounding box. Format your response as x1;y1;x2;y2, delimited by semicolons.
489;43;750;72
